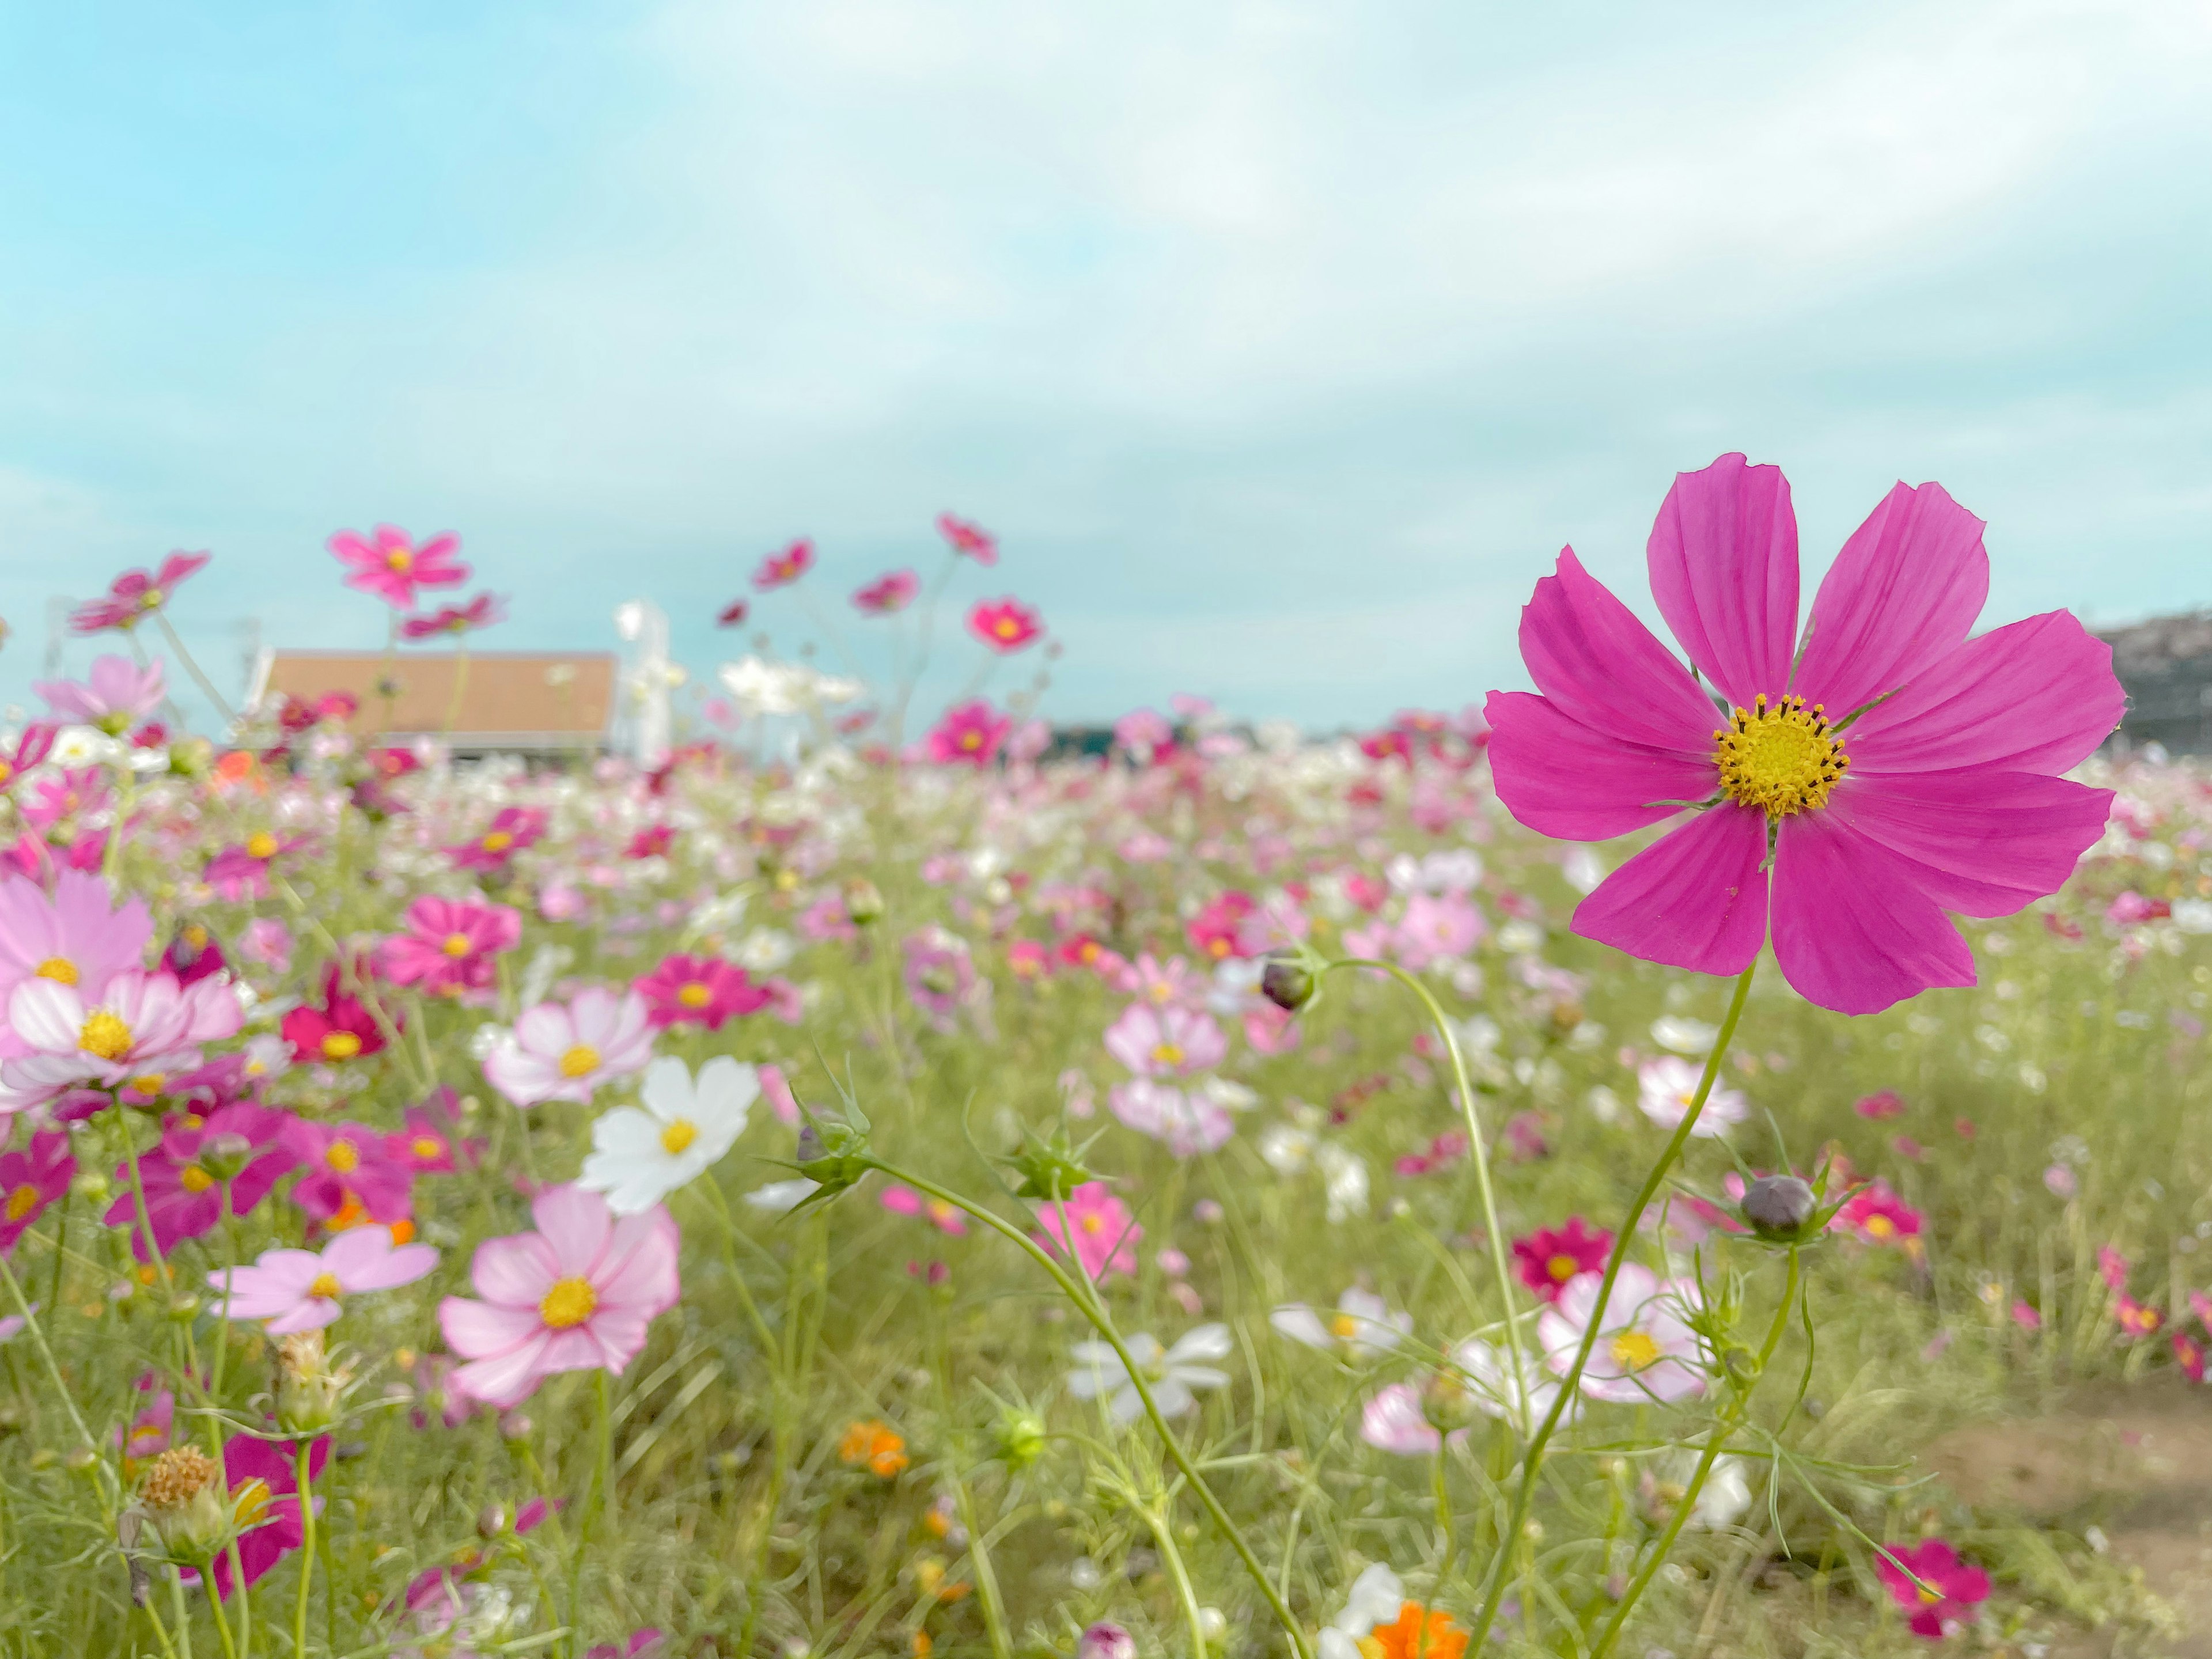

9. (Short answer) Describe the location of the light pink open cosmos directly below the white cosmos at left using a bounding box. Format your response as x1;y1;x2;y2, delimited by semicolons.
438;1185;681;1411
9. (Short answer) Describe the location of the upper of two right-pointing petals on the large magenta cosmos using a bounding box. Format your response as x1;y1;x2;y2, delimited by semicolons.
1843;611;2128;777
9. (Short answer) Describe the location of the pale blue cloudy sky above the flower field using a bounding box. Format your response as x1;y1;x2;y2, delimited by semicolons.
0;0;2212;726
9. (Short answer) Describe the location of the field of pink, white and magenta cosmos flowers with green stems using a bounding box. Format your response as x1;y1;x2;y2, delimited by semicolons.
0;471;2212;1659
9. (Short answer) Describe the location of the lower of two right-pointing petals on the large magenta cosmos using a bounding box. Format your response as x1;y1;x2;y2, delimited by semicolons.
1827;770;2112;916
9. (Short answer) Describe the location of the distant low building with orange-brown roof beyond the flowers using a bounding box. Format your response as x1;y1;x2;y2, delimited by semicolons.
248;650;615;756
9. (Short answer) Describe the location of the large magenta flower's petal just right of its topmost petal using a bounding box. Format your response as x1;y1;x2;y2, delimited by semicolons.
1791;484;1988;719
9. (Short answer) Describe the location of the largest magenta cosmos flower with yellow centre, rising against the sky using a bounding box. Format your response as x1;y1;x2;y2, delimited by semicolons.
1484;456;2123;1013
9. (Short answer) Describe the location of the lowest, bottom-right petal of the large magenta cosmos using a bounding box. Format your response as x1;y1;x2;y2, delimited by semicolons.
1774;812;1973;1013
